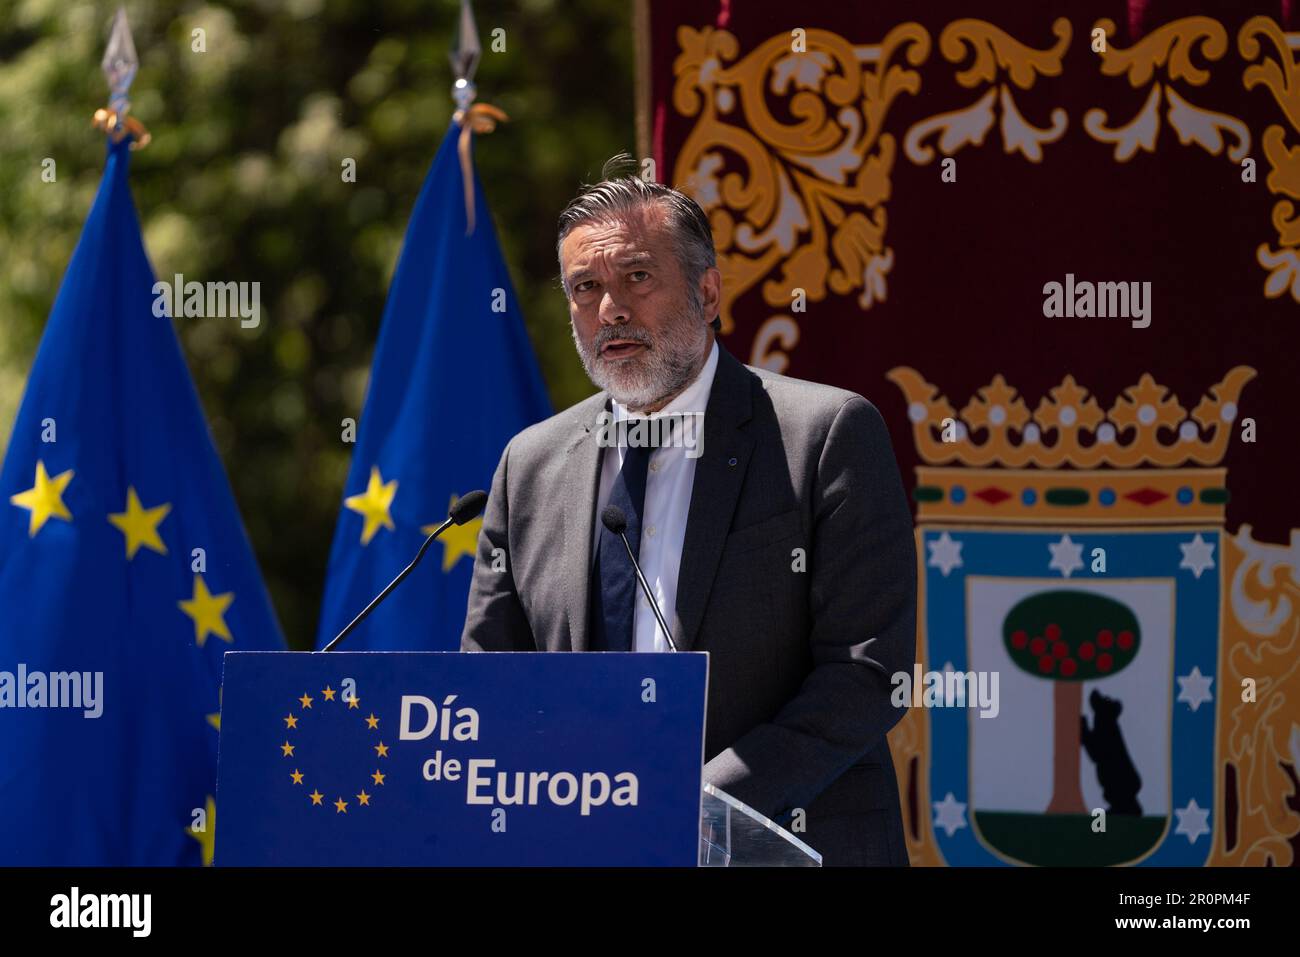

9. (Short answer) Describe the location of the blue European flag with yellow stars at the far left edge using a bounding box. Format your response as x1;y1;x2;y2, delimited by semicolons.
0;139;283;866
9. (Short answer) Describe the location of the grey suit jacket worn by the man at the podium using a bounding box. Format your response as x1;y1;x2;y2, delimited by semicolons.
462;343;917;865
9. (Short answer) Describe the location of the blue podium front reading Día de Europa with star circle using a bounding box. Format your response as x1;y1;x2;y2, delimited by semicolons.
215;651;709;866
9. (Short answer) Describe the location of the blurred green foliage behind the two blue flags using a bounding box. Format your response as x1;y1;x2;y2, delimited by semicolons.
0;0;636;648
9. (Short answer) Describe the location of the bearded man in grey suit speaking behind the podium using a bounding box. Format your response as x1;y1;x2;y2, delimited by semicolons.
462;157;917;865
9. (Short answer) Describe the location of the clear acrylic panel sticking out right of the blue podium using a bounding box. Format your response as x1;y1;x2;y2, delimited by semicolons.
699;784;822;867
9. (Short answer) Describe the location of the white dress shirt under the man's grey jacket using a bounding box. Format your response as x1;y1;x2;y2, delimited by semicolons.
592;341;718;651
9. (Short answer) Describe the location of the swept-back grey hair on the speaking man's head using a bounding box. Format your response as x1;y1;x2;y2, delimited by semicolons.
555;153;720;329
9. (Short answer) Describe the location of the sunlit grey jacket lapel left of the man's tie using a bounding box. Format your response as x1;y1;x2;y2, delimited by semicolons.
561;393;608;651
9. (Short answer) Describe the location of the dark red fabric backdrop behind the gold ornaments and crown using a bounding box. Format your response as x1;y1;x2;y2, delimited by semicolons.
650;0;1300;544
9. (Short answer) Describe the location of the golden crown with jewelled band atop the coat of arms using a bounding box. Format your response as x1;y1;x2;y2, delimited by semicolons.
887;365;1256;524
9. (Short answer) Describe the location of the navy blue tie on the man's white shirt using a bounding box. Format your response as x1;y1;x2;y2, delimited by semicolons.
590;446;654;651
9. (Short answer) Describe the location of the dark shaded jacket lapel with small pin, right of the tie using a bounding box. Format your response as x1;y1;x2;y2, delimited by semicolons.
676;343;755;651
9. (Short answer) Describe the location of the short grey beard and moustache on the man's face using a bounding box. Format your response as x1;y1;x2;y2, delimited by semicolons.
569;295;709;411
